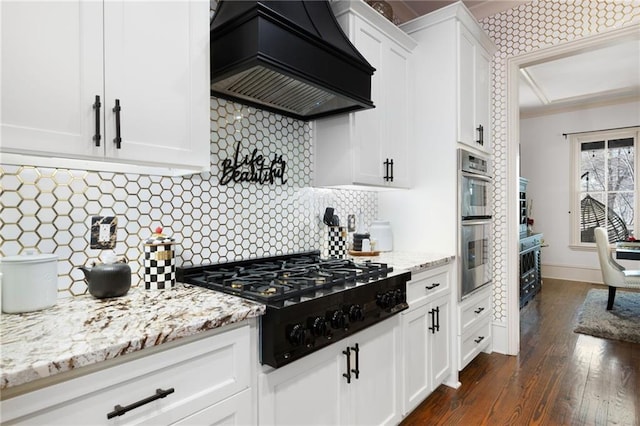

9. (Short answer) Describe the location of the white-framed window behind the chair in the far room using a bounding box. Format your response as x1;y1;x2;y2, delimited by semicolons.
571;128;640;247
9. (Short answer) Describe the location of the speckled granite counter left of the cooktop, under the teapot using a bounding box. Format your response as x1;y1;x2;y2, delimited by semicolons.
0;284;265;390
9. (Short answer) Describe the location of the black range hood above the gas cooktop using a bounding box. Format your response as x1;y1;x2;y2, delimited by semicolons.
211;0;375;121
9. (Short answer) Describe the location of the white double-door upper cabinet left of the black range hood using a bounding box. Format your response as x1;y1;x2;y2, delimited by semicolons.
0;0;210;174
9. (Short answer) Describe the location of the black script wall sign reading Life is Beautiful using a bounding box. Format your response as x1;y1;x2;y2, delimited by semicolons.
220;142;287;185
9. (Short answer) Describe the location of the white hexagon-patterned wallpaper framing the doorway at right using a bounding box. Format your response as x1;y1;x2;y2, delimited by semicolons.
480;0;640;322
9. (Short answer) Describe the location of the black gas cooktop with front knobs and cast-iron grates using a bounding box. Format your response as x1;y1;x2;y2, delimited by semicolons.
176;251;411;368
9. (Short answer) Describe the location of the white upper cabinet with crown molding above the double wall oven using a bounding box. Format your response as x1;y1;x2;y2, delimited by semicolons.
401;2;496;157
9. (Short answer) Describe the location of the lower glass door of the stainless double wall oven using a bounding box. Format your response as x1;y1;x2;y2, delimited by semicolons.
460;220;492;299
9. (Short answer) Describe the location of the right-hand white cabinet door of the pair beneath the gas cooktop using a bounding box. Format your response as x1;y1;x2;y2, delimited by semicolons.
347;315;400;425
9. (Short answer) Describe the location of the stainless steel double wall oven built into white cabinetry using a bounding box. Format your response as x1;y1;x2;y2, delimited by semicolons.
458;149;492;299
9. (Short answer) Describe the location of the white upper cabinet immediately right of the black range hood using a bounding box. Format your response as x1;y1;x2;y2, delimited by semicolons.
314;1;415;188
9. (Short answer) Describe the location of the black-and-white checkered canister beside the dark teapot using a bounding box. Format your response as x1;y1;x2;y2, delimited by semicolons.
144;233;176;290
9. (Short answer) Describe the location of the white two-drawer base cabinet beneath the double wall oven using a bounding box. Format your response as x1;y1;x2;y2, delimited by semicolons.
458;287;492;370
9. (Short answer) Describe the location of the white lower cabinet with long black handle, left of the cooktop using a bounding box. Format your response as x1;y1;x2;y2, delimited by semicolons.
0;325;256;425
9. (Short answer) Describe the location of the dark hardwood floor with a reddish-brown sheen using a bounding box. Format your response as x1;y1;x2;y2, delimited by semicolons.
401;279;640;426
